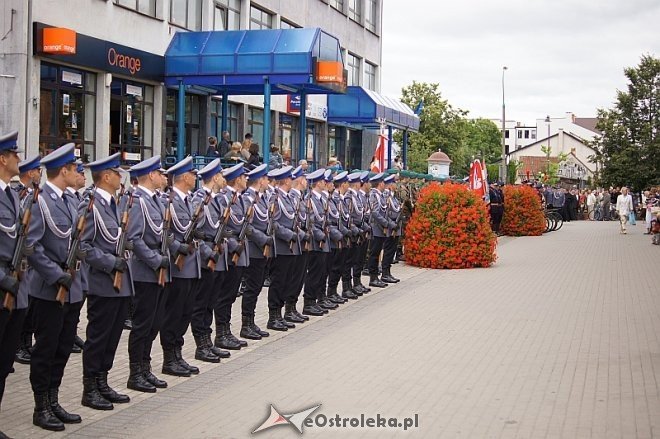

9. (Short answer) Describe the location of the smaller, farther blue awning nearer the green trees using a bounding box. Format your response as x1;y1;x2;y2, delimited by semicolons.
328;87;419;131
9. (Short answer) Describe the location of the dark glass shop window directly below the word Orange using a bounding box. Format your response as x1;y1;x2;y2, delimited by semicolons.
110;78;154;164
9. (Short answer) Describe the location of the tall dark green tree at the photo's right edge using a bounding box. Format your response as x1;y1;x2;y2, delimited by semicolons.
593;55;660;191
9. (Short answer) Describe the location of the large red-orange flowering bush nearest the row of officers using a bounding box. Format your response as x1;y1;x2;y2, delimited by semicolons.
404;183;497;268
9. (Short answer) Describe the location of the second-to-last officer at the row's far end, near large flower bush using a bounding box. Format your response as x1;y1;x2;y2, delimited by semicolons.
369;172;395;288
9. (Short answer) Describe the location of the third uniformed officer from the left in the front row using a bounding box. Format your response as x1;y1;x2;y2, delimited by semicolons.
81;153;133;410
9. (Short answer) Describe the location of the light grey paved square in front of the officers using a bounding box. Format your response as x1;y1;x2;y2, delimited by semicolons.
0;222;660;438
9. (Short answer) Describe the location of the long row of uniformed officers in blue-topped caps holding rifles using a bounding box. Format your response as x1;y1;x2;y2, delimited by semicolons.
0;133;405;437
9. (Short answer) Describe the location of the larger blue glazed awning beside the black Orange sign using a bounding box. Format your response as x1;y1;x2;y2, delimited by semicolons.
165;28;343;95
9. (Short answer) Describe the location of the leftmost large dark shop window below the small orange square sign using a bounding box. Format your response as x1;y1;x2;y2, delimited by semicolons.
39;62;96;162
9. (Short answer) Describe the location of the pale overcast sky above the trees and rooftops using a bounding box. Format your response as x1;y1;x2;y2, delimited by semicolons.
381;0;660;124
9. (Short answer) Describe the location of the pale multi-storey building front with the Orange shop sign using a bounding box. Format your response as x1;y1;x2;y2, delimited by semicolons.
0;0;382;166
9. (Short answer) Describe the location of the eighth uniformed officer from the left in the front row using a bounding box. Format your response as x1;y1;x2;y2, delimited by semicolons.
240;164;274;340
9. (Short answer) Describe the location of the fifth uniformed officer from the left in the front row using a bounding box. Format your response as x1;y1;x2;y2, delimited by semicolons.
160;156;201;376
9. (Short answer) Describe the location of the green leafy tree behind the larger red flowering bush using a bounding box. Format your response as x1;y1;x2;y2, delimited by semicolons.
397;81;467;173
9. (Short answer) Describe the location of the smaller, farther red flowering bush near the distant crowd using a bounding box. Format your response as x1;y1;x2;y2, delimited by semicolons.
501;186;545;236
